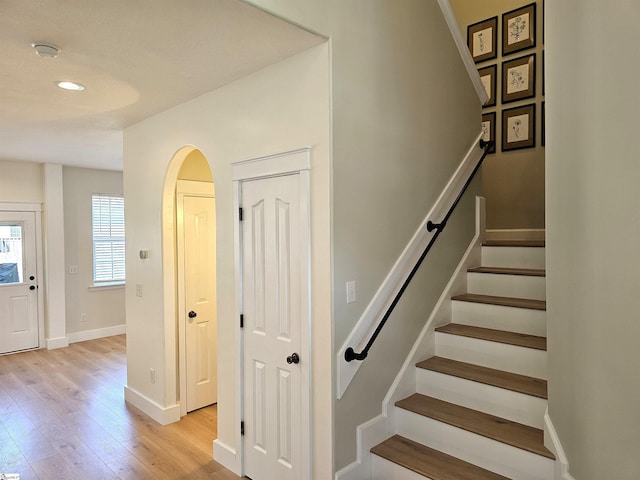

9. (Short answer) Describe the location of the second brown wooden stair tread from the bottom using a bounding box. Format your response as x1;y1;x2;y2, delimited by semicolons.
396;393;555;460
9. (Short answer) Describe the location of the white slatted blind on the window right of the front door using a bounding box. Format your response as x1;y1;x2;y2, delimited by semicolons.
91;194;125;284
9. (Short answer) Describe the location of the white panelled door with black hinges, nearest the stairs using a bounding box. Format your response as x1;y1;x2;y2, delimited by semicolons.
241;175;310;480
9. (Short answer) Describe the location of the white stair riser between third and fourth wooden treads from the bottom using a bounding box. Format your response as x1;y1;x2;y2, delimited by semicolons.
436;332;547;380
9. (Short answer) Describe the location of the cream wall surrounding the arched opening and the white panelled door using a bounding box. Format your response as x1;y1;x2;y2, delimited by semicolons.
124;44;332;479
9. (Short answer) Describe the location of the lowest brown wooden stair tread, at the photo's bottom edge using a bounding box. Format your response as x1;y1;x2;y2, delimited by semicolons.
371;435;509;480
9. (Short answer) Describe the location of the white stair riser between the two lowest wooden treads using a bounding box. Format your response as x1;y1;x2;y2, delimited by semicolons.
396;408;554;480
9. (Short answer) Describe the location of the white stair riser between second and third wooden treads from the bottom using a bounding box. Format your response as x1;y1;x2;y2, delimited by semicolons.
416;368;547;429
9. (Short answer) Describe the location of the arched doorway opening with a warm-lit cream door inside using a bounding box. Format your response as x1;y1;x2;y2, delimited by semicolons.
163;147;217;416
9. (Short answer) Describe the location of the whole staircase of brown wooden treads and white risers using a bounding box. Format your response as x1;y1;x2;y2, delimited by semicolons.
371;242;555;480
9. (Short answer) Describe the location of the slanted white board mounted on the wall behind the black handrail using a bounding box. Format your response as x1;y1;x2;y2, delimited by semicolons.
336;136;483;398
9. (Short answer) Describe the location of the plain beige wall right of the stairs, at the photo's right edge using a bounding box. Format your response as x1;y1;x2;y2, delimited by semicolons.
546;0;640;480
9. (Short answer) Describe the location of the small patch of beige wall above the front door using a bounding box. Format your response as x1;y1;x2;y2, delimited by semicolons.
0;161;44;203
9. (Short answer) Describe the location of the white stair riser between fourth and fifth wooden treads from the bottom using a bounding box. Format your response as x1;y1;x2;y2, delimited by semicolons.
451;300;547;337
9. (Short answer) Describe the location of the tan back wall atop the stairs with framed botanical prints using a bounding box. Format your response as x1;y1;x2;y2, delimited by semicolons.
449;0;545;229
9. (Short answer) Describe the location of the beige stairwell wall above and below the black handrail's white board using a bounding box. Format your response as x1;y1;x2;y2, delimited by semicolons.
252;0;480;469
